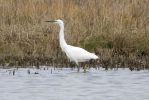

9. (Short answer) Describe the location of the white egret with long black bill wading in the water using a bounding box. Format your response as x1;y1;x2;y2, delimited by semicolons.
46;19;98;71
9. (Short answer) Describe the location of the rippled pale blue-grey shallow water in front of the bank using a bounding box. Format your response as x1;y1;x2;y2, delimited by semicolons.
0;68;149;100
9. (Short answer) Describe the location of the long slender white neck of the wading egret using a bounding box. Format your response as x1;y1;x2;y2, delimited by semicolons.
59;24;67;50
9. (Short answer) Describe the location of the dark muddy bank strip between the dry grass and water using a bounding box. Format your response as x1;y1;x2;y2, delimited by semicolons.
0;51;149;71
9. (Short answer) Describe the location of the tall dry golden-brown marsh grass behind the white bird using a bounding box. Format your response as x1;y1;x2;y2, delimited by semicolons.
0;0;149;69
